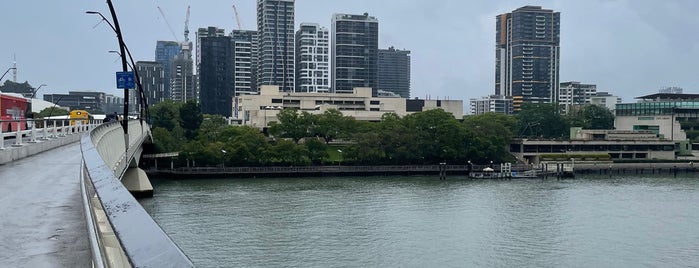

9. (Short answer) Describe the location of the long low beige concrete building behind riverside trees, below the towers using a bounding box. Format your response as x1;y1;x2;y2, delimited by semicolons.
233;86;463;128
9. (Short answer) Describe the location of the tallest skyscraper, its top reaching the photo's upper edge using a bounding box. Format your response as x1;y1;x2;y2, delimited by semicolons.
257;0;295;92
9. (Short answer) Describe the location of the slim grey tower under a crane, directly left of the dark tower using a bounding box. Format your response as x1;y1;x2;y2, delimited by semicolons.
169;42;198;102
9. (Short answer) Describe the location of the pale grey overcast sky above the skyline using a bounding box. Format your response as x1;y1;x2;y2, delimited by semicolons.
0;0;699;110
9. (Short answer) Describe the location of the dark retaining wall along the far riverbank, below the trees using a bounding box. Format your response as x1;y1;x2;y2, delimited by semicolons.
146;162;699;179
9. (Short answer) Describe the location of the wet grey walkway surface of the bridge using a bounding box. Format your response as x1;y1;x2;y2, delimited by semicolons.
0;142;90;267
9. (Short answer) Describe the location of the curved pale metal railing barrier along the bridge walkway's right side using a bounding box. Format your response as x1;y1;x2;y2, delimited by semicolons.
80;120;194;267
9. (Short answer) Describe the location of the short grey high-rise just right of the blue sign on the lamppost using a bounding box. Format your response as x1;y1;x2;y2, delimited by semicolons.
135;61;167;108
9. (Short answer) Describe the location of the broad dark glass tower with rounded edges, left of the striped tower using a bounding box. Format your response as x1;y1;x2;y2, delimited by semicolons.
197;27;235;117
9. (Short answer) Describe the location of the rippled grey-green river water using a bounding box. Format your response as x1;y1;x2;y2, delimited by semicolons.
141;175;699;267
